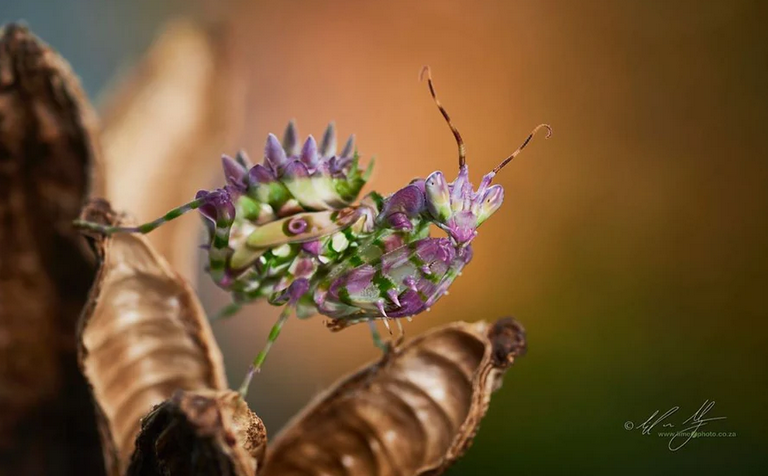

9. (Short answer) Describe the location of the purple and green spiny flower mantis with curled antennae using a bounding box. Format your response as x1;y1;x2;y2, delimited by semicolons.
75;67;552;395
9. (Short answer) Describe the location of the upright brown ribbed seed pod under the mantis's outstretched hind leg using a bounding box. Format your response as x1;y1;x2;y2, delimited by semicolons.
79;201;232;474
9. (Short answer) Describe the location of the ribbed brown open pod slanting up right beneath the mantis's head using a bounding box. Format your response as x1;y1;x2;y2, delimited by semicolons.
262;318;525;476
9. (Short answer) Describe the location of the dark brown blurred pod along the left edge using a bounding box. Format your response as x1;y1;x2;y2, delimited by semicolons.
0;25;103;475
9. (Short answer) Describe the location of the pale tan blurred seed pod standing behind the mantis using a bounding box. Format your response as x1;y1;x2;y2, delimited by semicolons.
97;20;246;280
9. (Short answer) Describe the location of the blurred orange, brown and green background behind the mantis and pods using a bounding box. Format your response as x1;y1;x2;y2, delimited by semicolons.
0;0;768;475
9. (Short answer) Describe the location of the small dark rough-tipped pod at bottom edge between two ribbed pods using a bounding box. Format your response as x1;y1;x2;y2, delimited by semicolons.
128;391;267;476
